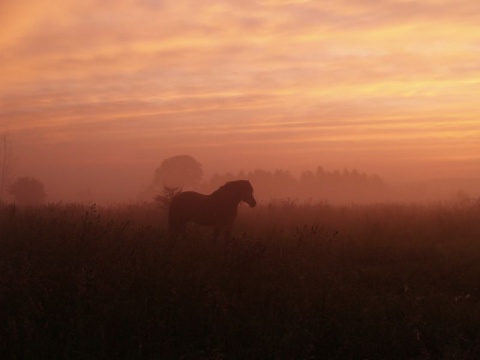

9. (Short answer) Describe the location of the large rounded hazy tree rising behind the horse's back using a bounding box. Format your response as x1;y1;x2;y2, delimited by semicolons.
152;155;203;190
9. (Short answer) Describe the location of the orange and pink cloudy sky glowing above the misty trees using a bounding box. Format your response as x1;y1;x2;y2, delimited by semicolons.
0;0;480;201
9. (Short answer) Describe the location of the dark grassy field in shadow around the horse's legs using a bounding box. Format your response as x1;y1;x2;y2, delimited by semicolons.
0;201;480;359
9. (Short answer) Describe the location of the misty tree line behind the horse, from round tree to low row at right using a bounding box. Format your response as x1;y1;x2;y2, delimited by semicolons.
150;155;386;201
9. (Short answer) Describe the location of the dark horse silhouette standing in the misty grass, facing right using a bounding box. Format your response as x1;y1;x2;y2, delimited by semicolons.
168;180;257;240
